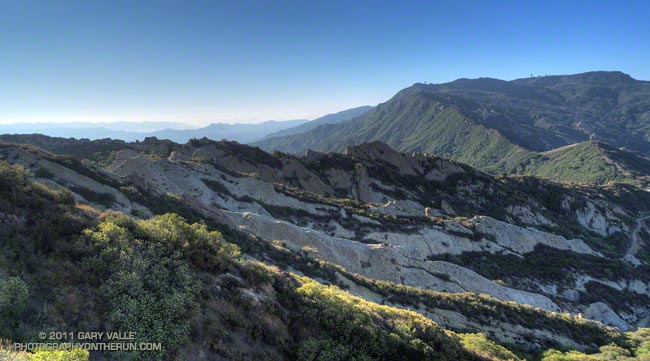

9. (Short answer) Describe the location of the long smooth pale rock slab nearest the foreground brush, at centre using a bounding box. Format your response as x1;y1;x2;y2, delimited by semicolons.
224;212;559;311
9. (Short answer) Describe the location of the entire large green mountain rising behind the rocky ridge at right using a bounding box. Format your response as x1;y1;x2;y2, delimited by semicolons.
256;72;650;187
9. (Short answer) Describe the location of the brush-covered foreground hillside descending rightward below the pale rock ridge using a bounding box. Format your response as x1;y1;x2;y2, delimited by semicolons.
0;162;648;361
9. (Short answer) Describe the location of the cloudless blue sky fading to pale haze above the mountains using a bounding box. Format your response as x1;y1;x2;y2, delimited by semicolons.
0;0;650;124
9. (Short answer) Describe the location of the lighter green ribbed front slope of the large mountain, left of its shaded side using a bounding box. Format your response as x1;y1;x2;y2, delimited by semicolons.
262;87;532;171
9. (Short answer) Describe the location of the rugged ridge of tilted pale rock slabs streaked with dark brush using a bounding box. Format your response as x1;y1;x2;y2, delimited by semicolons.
3;136;650;346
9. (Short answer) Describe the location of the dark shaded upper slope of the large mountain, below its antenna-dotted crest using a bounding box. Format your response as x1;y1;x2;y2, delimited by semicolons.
427;71;650;154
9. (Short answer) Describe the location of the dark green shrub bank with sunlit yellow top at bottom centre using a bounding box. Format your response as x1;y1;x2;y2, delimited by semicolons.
284;278;477;360
